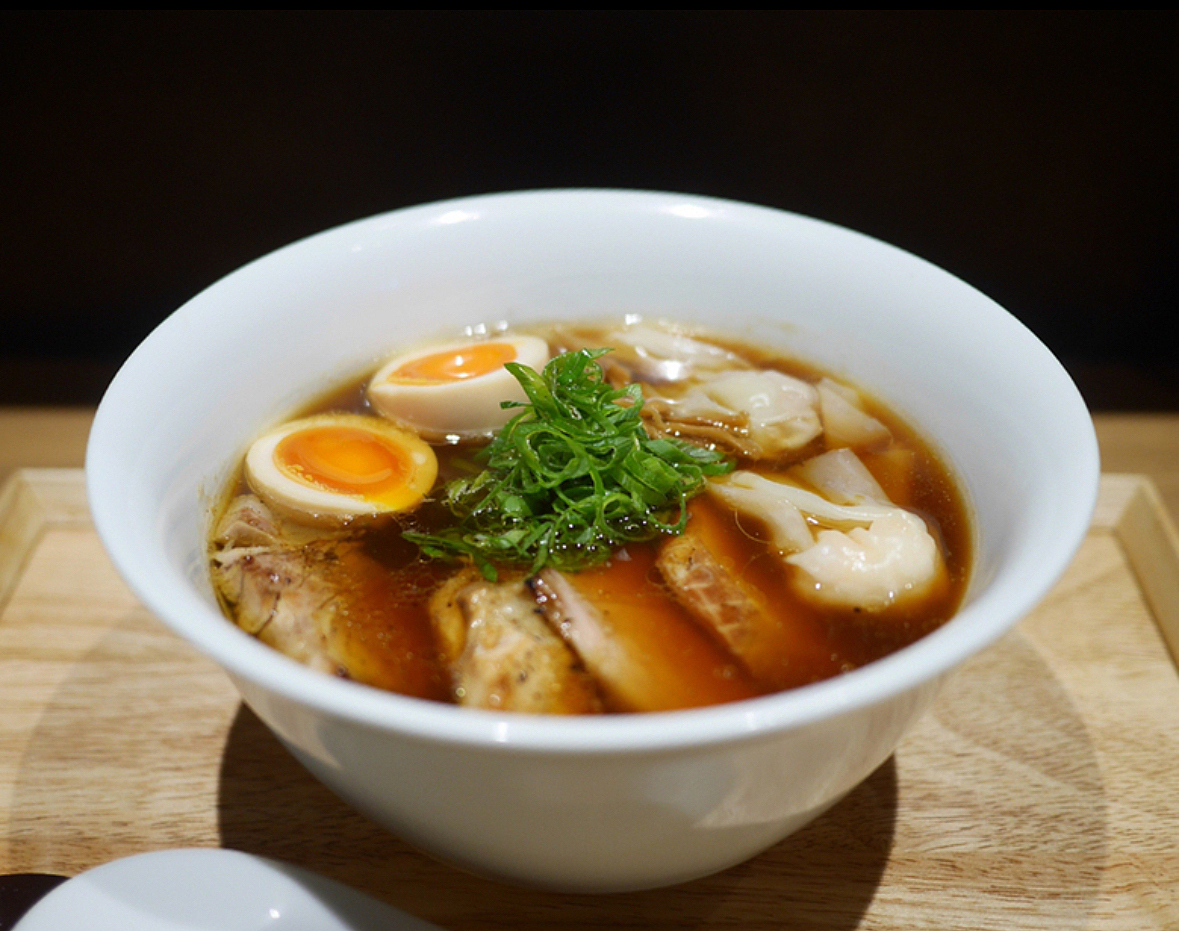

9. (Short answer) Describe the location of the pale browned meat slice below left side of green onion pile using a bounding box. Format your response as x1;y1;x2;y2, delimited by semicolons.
430;569;601;714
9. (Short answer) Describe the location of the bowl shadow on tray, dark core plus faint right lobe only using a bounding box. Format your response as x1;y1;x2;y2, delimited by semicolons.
218;622;1117;931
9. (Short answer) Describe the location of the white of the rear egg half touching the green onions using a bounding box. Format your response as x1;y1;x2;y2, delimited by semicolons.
368;336;548;442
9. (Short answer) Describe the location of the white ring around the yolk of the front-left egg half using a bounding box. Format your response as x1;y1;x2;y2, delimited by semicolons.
245;414;437;526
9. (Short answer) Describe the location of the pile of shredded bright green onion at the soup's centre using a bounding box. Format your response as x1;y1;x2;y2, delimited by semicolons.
406;349;732;581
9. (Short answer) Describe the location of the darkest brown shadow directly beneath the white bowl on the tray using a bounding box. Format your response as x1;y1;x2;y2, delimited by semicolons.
218;705;897;930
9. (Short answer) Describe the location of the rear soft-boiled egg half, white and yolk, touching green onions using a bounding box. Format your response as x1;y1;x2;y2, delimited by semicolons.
368;336;548;442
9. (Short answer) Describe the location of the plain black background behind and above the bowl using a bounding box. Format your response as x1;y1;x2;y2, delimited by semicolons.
0;12;1179;410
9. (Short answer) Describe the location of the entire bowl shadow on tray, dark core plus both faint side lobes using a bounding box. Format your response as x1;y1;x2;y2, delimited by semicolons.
0;603;1103;931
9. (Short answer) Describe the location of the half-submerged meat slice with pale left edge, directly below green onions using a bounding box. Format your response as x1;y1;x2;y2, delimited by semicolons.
528;557;758;711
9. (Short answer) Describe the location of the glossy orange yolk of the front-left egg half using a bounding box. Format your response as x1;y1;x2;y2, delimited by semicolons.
275;425;421;508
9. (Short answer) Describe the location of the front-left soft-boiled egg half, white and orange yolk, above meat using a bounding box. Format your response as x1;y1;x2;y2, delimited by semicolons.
245;414;439;524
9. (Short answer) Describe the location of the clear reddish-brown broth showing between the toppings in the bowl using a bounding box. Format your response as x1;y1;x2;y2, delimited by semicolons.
216;325;971;711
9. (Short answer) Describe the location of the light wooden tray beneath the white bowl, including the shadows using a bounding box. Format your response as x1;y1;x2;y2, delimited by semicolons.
0;470;1179;931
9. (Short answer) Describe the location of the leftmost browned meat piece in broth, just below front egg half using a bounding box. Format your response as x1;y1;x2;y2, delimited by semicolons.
211;495;446;699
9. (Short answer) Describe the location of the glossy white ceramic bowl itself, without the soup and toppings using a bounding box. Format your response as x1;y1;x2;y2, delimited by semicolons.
86;191;1098;891
